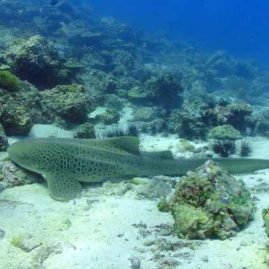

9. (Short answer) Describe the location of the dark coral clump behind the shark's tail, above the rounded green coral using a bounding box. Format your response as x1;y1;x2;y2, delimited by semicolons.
168;95;254;139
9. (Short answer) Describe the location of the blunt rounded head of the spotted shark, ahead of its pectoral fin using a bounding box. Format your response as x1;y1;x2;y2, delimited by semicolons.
7;140;41;172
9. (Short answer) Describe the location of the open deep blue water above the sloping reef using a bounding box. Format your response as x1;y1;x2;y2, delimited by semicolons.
88;0;269;64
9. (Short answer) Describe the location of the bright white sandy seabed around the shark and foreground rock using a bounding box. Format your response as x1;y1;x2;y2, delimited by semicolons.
0;135;269;269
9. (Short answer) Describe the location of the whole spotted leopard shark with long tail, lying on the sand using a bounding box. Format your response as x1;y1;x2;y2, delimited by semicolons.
8;136;269;201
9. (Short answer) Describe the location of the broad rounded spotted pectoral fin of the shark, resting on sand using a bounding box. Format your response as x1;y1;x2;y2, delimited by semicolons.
44;174;81;201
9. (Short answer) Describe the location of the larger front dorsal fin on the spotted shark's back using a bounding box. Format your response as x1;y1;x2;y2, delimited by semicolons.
106;136;140;154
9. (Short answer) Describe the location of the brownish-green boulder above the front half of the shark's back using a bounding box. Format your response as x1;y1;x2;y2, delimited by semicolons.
41;84;90;123
